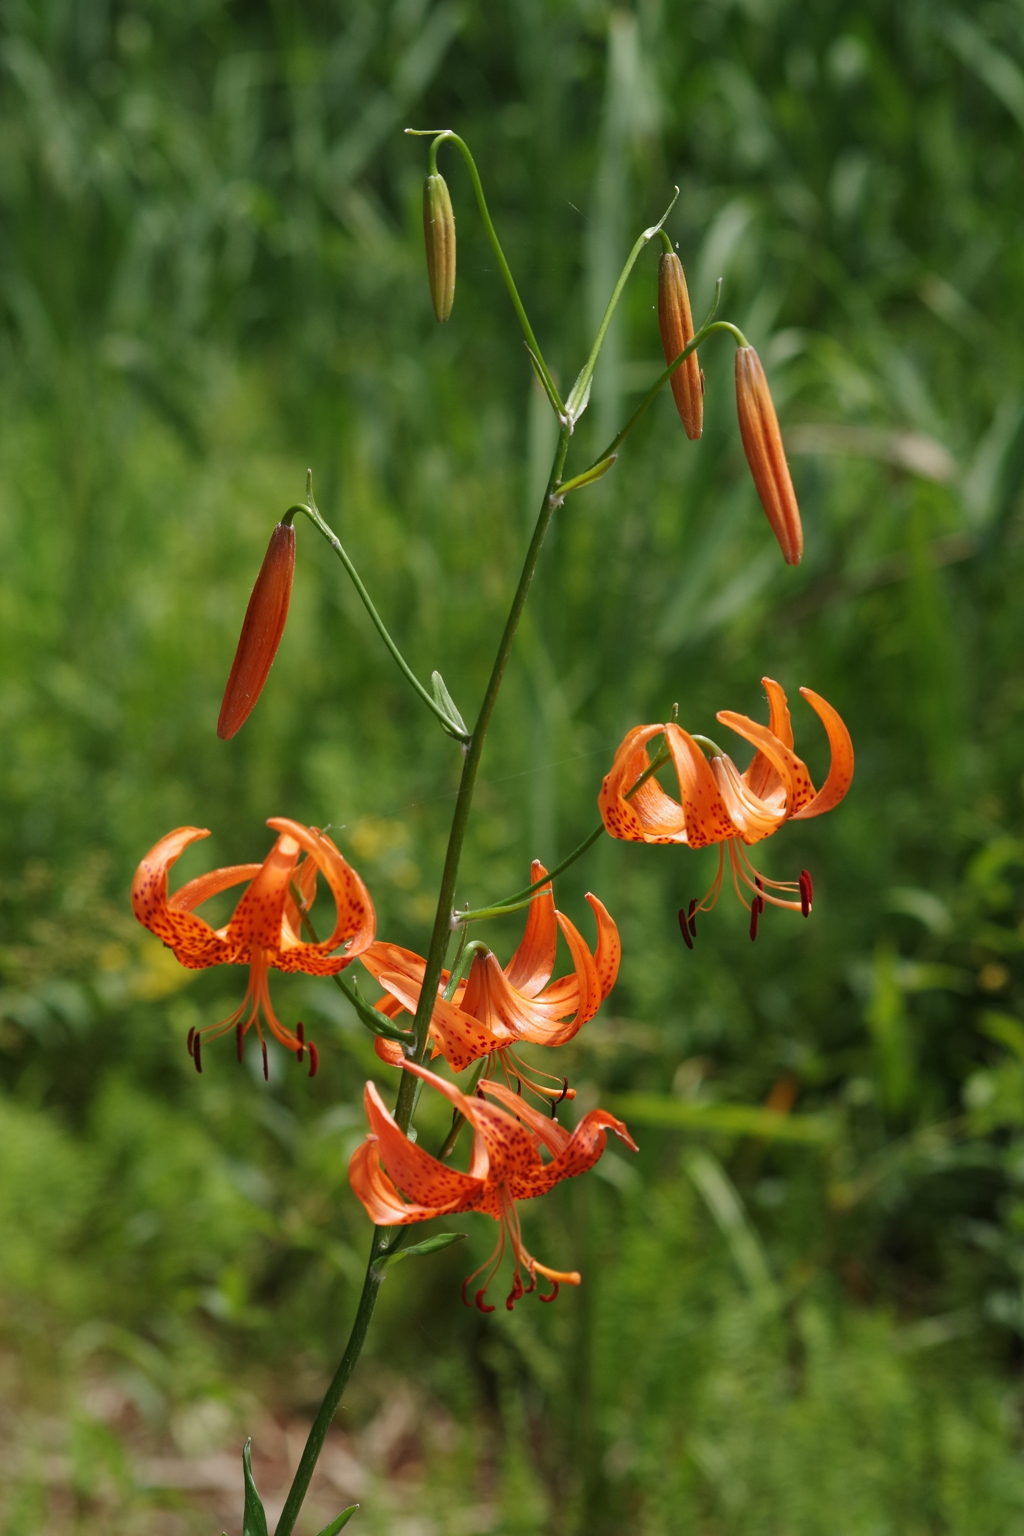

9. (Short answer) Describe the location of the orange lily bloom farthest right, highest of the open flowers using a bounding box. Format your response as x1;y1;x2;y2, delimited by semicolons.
597;677;854;948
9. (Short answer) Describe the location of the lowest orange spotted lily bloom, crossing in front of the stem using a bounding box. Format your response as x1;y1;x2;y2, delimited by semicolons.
348;1061;637;1312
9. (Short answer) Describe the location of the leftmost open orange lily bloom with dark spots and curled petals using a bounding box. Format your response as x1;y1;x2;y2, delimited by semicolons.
132;816;376;1077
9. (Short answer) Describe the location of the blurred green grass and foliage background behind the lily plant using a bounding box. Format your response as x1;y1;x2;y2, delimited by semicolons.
0;0;1024;1536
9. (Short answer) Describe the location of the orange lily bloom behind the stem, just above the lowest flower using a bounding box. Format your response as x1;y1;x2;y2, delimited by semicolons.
359;859;622;1100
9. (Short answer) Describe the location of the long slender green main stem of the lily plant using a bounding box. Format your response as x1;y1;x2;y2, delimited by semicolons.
276;427;570;1536
